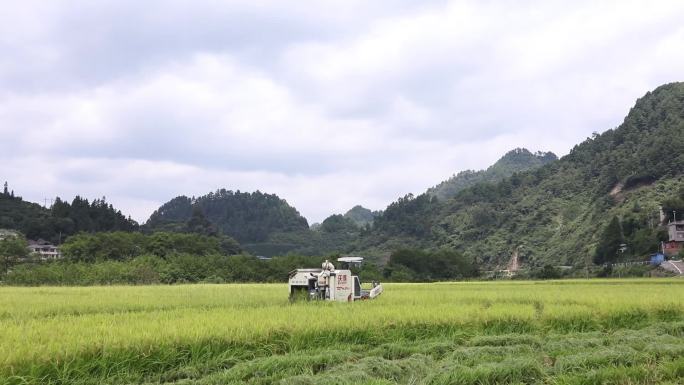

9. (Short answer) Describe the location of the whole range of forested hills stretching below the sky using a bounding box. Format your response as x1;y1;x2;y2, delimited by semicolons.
0;83;684;275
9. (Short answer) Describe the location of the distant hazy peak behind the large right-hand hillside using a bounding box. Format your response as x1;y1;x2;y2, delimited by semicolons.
427;148;558;200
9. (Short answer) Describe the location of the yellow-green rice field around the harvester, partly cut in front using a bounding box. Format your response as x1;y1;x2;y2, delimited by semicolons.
0;279;684;385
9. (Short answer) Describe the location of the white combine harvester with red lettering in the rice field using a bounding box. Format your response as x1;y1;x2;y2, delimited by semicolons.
289;257;382;302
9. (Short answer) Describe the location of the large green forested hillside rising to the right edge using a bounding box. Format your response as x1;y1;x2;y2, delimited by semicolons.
360;83;684;267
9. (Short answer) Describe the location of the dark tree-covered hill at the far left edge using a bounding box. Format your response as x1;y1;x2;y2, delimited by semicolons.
0;187;138;242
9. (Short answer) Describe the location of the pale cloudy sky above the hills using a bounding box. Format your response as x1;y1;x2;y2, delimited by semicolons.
0;0;684;223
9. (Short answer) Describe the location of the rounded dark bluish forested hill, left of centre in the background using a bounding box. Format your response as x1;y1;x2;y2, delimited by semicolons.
144;189;308;243
